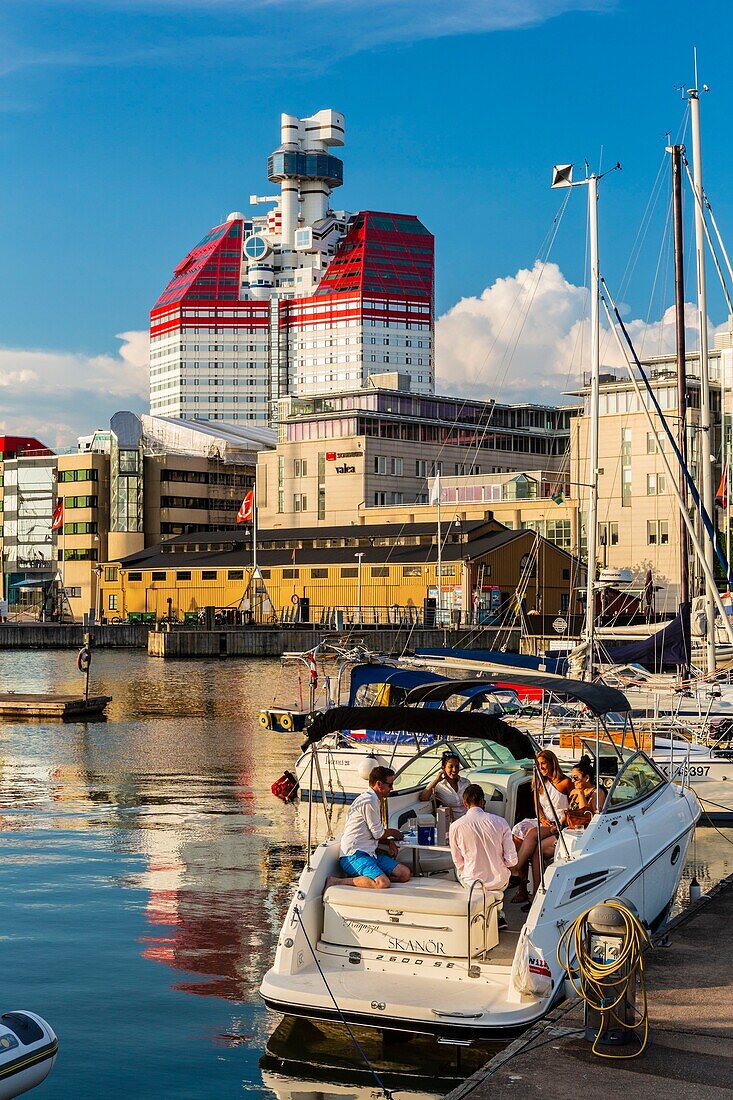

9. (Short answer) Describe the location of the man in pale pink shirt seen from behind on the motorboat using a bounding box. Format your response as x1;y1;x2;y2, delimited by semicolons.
448;783;517;890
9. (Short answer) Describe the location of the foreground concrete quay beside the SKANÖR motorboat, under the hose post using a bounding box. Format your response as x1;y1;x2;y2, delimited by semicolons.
445;876;733;1100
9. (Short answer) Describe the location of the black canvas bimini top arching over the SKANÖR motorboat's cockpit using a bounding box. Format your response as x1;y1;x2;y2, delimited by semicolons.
302;706;537;760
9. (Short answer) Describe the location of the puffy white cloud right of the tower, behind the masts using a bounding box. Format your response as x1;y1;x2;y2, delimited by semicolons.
436;263;697;404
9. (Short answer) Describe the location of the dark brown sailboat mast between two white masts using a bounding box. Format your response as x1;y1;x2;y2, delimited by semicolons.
668;145;690;604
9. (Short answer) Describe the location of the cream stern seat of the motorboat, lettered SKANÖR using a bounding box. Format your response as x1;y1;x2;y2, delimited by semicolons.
321;878;503;958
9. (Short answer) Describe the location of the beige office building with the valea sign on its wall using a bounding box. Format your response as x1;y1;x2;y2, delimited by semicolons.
258;382;570;529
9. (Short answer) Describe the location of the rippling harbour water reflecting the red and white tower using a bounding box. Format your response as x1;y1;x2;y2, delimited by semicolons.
0;651;733;1100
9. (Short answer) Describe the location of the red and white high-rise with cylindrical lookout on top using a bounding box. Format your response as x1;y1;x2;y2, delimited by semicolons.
150;110;435;425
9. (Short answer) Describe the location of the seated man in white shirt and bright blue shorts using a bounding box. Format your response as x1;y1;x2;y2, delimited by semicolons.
326;767;411;890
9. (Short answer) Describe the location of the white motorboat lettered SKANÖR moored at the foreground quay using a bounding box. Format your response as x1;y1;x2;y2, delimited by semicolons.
261;704;700;1043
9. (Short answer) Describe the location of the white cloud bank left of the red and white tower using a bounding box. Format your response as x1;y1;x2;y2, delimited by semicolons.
0;331;149;449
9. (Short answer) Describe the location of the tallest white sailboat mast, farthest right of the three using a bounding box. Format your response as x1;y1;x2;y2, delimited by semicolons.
688;81;715;673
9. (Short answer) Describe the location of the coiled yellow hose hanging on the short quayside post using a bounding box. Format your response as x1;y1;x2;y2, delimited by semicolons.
557;901;650;1058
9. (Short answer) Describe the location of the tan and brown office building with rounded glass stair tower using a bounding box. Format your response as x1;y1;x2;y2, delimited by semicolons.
54;413;274;618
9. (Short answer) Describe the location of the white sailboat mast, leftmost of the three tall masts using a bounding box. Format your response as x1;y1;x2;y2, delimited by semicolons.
586;175;601;680
